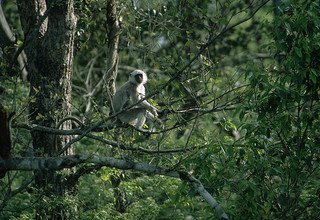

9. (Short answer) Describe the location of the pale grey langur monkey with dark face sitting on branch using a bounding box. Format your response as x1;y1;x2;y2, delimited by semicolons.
112;70;162;130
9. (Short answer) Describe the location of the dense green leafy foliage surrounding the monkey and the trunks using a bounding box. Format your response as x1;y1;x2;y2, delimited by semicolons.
0;0;320;219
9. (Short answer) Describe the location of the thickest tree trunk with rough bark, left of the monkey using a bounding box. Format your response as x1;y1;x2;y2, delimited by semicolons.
18;0;77;219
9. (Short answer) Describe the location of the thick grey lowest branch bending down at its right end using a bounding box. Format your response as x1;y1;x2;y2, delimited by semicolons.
0;155;228;219
